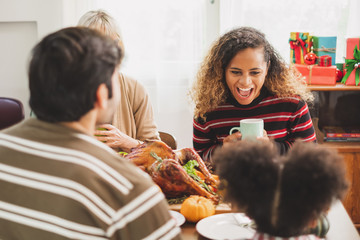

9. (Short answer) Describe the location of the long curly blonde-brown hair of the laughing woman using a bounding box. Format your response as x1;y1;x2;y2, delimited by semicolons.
190;27;313;119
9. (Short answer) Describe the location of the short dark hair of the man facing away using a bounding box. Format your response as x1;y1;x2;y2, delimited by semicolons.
29;27;123;122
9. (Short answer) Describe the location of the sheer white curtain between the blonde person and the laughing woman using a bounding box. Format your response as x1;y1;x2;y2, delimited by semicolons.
86;0;205;147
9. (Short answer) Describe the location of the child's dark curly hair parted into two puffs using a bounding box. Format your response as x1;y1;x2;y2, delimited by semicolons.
214;141;348;237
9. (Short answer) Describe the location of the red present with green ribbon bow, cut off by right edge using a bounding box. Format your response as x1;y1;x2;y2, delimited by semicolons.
341;38;360;86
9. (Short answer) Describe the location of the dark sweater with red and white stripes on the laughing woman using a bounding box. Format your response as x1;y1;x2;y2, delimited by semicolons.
193;87;316;163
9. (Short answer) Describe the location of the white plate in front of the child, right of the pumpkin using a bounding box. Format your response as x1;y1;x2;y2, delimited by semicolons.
196;213;255;240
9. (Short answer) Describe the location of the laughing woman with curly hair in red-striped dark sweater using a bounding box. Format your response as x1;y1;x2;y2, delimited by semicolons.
191;27;316;167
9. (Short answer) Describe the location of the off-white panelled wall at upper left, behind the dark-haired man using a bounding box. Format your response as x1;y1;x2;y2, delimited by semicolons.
0;0;92;117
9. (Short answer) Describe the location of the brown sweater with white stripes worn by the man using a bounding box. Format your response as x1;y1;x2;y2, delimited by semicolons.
0;119;180;240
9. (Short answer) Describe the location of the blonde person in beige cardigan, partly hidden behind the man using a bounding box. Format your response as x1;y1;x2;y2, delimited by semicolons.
78;10;159;152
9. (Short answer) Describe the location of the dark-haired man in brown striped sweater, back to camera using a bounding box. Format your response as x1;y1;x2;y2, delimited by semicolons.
0;27;180;240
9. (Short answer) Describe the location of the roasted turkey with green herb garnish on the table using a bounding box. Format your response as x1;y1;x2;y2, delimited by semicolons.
125;141;219;203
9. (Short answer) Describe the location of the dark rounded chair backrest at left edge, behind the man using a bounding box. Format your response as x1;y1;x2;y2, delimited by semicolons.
0;97;24;130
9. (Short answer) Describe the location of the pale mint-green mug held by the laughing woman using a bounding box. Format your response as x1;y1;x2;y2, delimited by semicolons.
230;118;264;140
